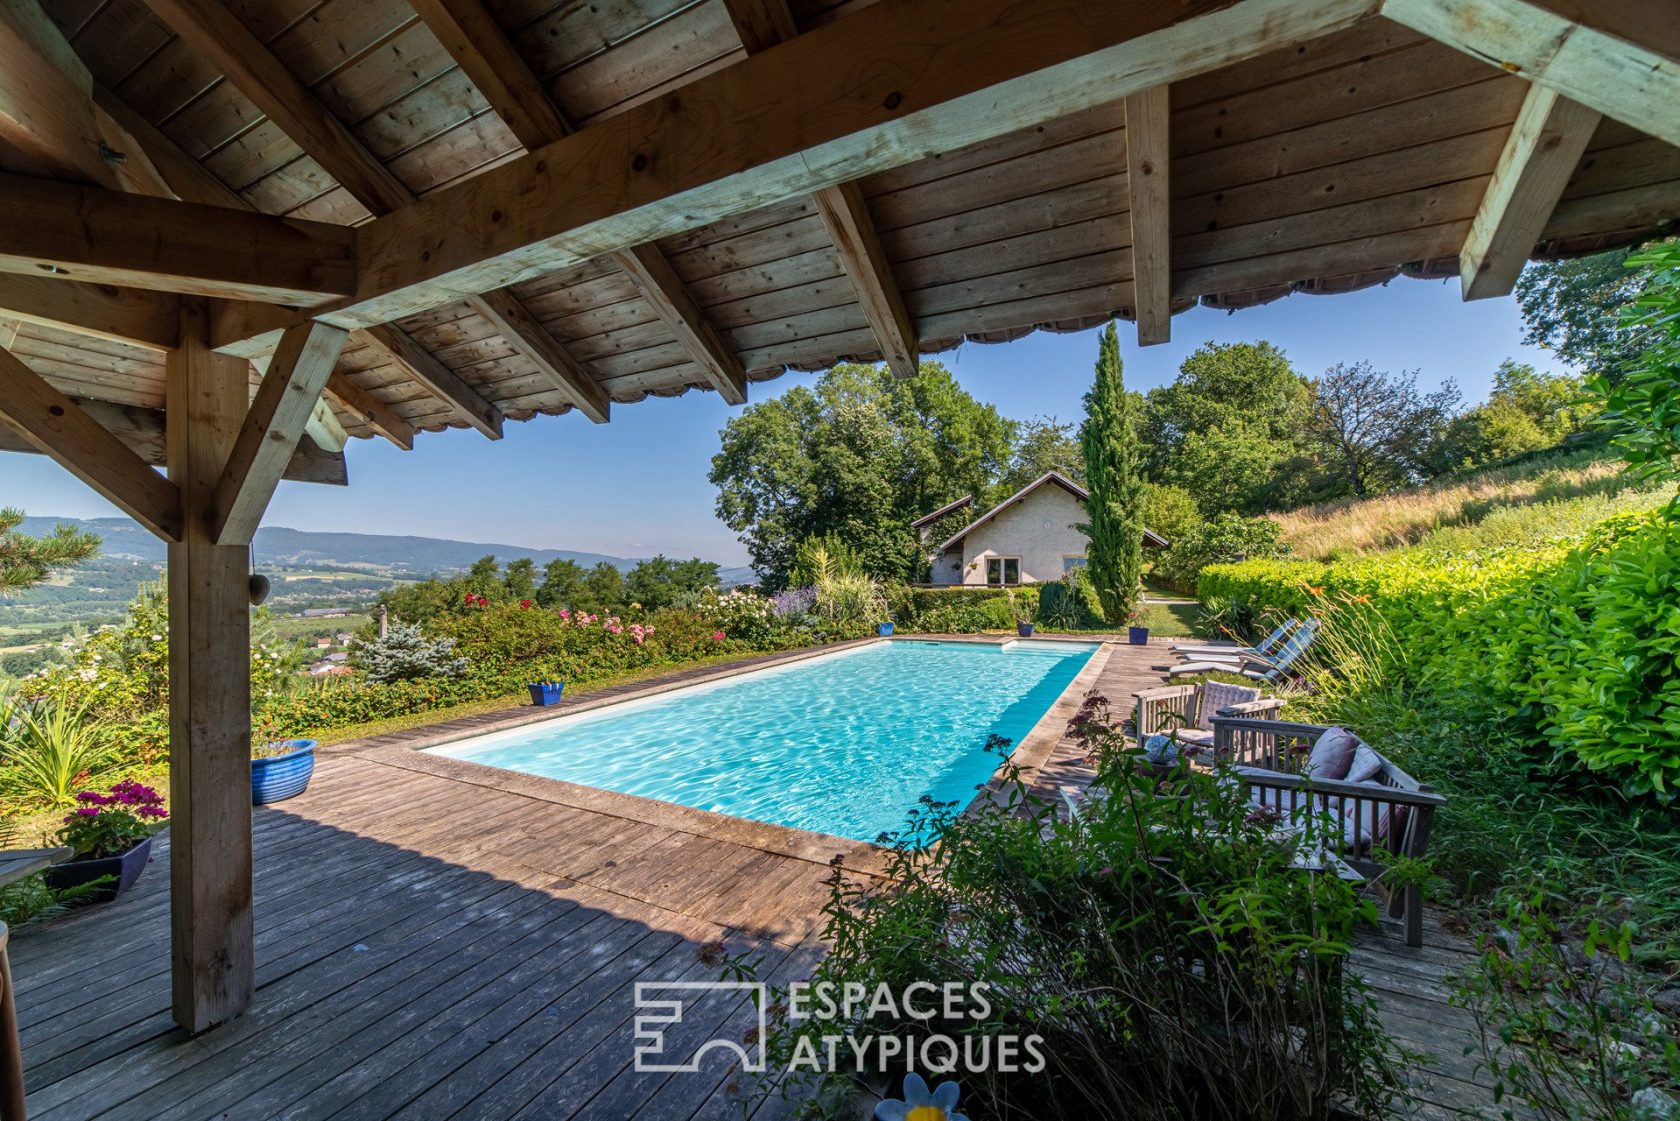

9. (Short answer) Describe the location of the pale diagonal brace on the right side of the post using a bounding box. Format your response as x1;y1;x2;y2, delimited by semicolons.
210;323;346;545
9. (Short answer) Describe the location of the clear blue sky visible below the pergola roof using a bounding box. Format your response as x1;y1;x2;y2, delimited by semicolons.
0;279;1559;565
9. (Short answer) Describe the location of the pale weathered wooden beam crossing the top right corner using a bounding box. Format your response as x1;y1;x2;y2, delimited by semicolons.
1383;0;1680;145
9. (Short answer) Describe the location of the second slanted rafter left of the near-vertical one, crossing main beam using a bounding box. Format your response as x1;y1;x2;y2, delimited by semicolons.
413;0;746;408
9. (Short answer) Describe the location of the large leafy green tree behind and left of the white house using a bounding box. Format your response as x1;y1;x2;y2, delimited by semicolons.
711;361;1013;590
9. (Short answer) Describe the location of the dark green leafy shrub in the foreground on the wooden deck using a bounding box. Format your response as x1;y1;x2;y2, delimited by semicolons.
726;697;1399;1121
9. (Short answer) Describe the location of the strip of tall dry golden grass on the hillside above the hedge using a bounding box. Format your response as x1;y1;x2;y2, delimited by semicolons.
1272;452;1673;560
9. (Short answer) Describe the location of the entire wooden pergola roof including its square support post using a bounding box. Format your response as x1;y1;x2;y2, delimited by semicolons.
0;0;1680;1032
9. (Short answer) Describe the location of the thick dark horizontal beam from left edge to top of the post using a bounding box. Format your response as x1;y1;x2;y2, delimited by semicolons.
0;175;356;304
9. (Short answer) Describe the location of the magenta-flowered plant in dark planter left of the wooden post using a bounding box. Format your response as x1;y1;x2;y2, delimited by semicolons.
42;780;170;903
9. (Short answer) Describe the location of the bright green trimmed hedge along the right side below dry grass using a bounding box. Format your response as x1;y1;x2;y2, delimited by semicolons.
1201;509;1680;800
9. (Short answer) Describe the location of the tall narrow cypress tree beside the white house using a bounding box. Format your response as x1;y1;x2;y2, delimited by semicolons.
1079;321;1144;625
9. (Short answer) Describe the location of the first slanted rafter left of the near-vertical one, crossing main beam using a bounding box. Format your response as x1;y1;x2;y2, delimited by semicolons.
726;0;919;378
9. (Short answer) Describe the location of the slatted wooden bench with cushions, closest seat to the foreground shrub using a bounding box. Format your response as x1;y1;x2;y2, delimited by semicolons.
1213;716;1446;946
